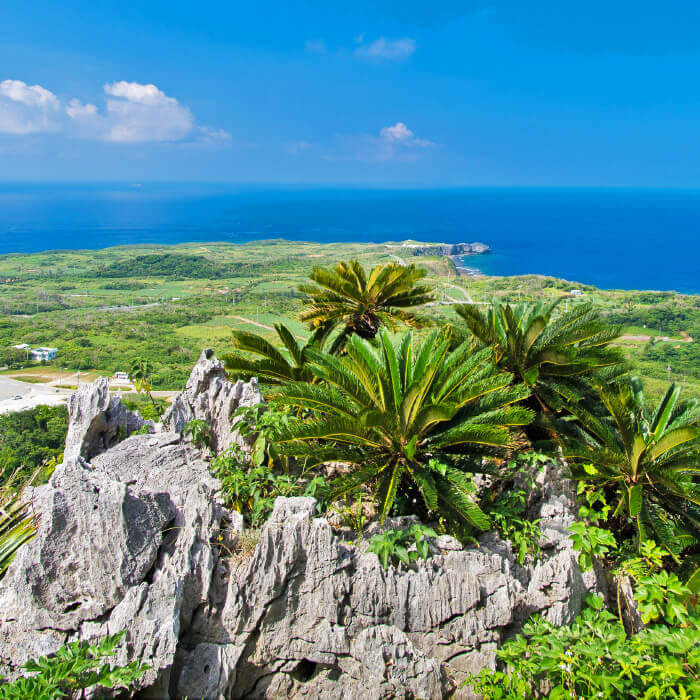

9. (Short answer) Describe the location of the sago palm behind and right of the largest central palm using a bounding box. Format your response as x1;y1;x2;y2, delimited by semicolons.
456;300;624;411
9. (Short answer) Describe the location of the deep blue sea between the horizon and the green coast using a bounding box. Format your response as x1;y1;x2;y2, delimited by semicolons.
0;184;700;293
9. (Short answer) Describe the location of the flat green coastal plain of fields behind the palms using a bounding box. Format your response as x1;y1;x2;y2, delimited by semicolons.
0;241;700;395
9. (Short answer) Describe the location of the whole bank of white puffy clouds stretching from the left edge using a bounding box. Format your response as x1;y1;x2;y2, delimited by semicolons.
0;80;231;144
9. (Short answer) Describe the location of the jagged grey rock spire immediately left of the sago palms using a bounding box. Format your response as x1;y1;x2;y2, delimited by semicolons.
163;349;263;454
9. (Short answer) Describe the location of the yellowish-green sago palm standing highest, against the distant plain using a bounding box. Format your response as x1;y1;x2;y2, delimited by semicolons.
299;260;433;342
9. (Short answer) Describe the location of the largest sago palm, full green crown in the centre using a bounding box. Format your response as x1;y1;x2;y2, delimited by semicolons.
276;329;532;529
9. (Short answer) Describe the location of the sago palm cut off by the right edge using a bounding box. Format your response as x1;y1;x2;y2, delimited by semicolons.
564;378;700;544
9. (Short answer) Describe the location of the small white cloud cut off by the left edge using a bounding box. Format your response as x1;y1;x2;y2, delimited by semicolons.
0;80;61;134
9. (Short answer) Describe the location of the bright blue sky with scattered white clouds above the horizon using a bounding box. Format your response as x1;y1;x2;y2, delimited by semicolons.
0;0;700;187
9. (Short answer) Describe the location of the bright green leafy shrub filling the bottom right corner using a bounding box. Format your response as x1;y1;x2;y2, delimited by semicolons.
467;597;700;700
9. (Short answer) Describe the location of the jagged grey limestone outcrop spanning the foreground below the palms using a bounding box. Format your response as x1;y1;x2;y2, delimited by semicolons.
0;353;595;700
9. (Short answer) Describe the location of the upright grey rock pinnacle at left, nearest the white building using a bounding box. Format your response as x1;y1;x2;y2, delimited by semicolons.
64;377;152;460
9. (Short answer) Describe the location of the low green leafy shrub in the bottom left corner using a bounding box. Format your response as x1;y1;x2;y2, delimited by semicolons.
0;632;149;700
